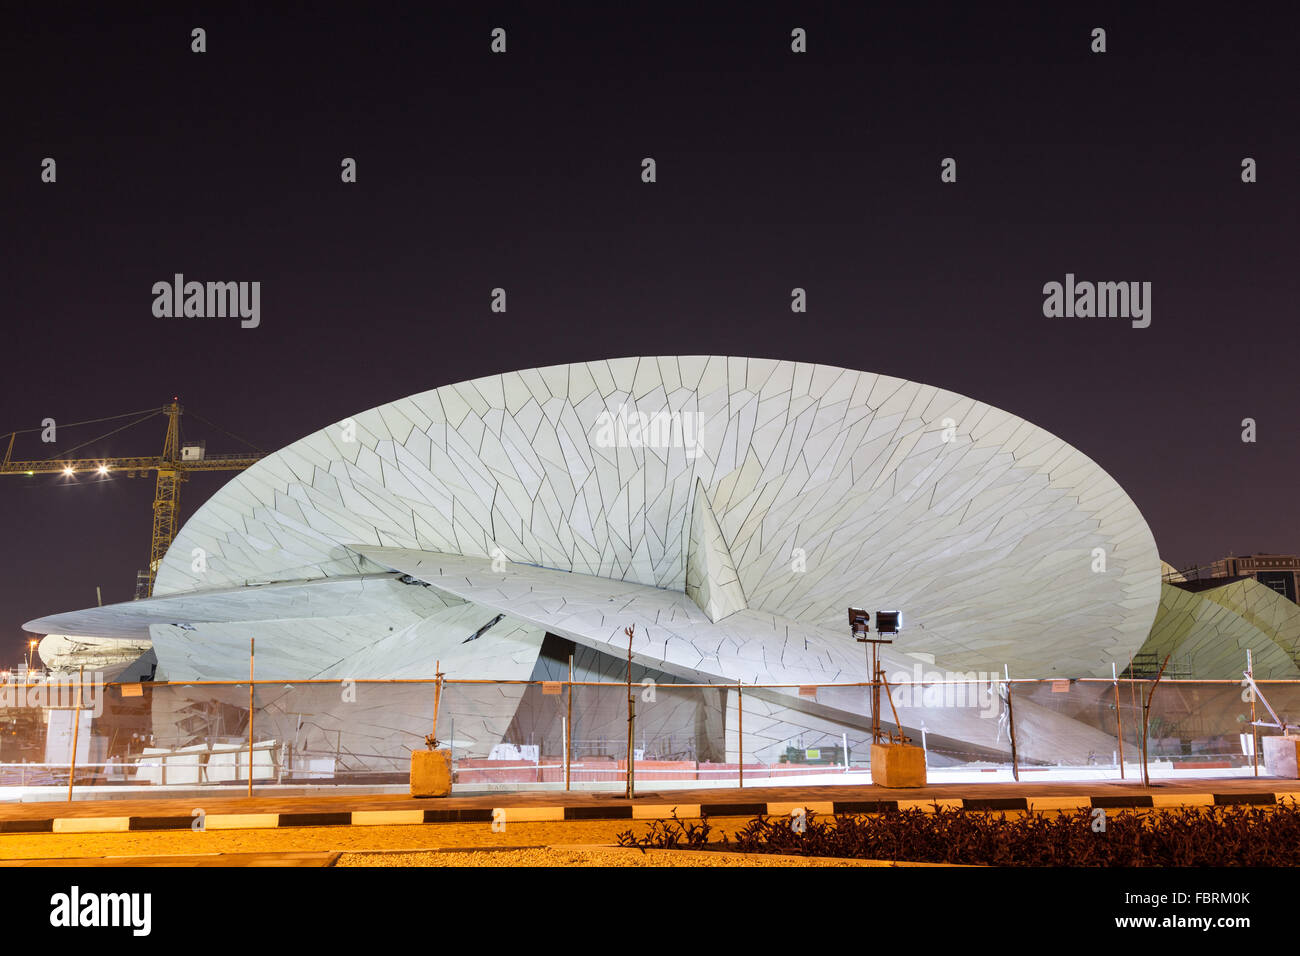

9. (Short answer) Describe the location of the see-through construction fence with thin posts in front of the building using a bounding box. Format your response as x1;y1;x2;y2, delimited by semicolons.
0;676;1300;800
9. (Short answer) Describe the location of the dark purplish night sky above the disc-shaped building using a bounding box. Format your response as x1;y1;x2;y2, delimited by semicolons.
0;3;1300;665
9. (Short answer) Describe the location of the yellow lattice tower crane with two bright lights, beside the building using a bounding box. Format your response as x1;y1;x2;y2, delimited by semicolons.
0;398;263;600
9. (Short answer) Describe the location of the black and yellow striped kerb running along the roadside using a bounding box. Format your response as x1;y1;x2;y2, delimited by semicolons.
0;791;1300;834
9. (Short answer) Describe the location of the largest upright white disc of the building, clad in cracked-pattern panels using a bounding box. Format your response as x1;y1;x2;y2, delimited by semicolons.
142;356;1160;676
